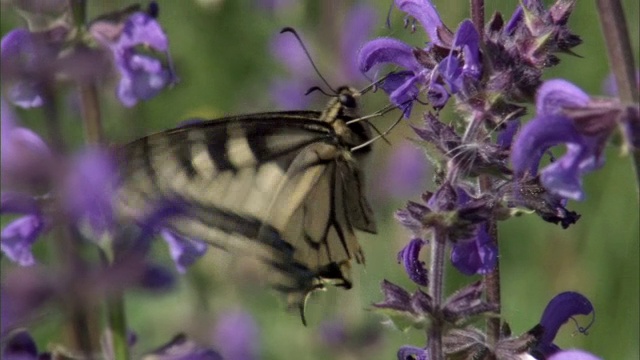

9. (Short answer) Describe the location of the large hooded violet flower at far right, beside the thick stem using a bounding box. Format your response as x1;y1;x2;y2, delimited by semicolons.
511;80;620;200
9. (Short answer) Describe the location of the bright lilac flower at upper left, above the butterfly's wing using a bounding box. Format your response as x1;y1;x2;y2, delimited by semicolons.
90;7;177;107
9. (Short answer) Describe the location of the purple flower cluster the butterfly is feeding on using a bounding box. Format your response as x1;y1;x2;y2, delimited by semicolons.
358;0;481;117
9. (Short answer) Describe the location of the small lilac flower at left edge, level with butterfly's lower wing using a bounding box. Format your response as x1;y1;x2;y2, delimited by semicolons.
0;193;48;266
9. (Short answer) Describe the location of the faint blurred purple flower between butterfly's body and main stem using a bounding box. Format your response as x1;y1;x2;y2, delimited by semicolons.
378;142;429;198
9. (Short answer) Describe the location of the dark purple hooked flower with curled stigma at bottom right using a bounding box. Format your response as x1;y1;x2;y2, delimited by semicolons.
535;291;593;357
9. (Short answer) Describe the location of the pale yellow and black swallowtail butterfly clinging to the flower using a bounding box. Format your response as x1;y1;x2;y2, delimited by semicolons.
115;87;376;322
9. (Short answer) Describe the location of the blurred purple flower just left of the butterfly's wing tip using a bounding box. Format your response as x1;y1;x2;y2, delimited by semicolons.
64;148;117;241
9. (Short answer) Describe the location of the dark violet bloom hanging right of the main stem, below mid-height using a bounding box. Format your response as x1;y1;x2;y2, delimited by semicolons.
451;225;498;275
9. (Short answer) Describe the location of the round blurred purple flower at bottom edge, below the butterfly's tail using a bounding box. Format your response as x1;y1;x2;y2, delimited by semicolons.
213;311;260;360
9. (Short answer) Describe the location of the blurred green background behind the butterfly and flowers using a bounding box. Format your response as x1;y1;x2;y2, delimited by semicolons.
2;0;640;360
